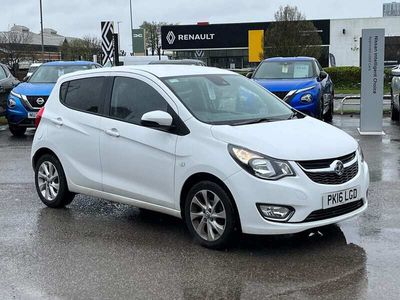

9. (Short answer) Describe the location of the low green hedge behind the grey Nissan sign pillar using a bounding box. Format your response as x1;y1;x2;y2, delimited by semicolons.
324;67;391;88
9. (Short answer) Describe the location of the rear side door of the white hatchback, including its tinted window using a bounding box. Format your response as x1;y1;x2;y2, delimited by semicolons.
45;76;107;191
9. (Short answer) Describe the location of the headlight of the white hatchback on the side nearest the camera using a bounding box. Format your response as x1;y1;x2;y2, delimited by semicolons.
228;145;295;180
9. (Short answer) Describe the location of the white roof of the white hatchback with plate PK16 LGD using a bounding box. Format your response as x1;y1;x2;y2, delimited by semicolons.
62;65;234;79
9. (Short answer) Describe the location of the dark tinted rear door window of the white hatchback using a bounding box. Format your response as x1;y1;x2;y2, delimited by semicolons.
60;77;104;113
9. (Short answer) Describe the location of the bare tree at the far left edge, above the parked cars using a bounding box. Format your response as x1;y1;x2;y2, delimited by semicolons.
0;30;33;67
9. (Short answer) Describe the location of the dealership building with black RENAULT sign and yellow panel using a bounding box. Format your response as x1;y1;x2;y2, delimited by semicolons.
161;17;400;69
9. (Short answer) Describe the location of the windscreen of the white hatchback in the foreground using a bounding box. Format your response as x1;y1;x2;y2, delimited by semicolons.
164;74;293;125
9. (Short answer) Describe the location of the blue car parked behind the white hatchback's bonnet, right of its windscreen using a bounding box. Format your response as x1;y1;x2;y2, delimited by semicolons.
251;57;334;122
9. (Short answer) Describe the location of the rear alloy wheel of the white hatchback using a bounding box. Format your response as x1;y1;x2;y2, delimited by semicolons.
37;161;60;201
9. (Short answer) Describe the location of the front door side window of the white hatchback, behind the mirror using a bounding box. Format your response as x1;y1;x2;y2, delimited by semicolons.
110;77;168;125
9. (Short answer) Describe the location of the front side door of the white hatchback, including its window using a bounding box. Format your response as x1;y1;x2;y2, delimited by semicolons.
100;75;177;208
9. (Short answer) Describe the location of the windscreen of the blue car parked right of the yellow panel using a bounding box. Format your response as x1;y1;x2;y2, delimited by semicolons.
253;61;316;79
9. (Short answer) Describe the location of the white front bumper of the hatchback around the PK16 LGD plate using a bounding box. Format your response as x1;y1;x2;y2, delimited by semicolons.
225;161;369;234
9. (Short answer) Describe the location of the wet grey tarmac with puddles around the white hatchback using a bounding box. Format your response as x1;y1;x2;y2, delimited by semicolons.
0;116;400;299
